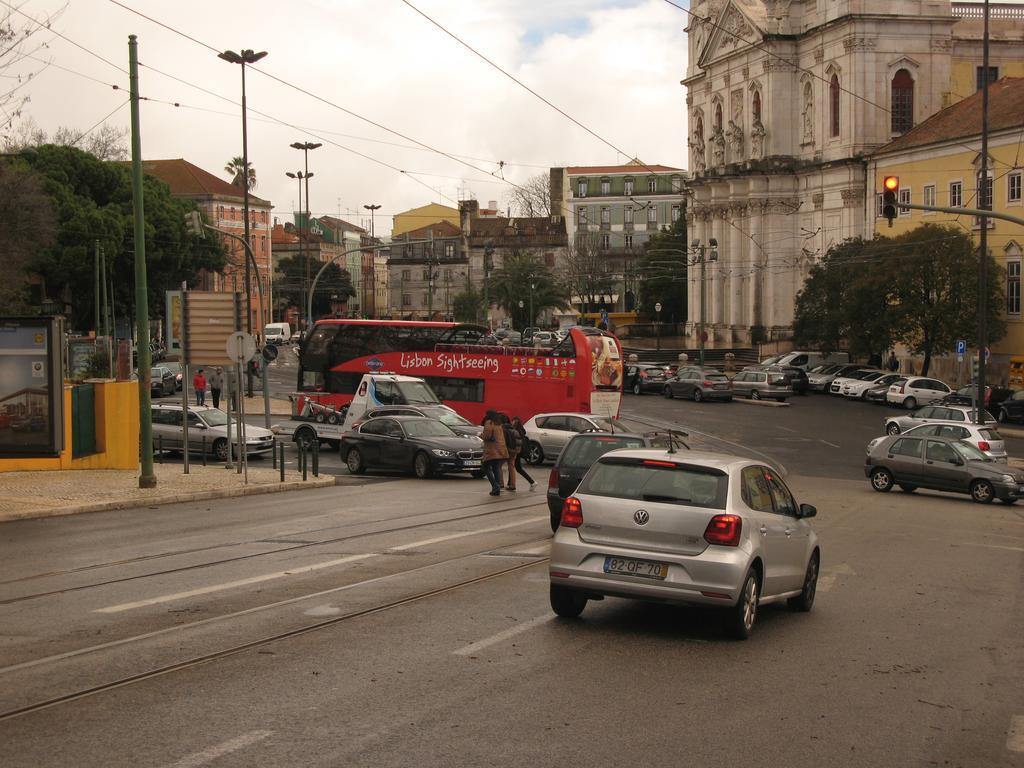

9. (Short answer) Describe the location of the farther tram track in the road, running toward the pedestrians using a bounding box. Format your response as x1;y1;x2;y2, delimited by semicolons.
0;498;543;606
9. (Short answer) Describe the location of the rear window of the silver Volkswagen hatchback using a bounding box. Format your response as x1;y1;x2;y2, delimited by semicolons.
579;456;729;509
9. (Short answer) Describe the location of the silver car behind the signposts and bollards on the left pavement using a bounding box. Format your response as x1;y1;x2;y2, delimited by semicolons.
152;403;273;461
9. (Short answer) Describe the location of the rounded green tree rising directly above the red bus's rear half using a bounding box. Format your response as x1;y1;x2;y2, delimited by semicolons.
487;251;568;329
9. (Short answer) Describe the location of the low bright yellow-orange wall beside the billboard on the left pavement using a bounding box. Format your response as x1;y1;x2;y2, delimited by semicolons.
0;381;139;472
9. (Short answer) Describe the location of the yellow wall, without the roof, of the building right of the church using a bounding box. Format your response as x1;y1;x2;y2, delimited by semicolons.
872;137;1024;354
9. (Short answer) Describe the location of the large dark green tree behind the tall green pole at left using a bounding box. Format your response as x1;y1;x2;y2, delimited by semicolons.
22;144;226;331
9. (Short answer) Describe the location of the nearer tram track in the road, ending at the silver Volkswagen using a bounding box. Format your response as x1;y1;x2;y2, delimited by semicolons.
0;539;548;722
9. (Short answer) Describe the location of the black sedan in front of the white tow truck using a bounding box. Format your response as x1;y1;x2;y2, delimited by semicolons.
341;416;483;477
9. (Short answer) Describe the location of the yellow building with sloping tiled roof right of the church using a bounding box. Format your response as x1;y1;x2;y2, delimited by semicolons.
866;77;1024;360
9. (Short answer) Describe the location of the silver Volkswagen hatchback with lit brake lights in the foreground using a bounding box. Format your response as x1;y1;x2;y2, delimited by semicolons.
549;450;821;639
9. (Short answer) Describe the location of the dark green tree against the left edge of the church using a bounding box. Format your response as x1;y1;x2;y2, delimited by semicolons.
637;215;688;323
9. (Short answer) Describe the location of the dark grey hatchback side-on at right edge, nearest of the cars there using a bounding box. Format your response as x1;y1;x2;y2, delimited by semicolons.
864;435;1024;504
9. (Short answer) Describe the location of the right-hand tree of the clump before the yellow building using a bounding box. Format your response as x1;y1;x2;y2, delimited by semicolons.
876;224;1007;375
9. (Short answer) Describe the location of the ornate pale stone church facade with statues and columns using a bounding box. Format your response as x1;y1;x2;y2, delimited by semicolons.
682;0;1021;346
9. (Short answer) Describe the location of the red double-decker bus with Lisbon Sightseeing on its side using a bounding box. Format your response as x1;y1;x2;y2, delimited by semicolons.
298;319;623;424
